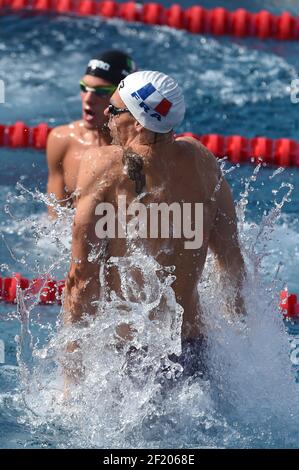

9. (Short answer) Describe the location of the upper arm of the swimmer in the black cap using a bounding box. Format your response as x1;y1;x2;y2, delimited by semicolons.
46;128;67;218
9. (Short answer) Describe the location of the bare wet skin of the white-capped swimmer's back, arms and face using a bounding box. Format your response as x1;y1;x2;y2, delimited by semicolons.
64;92;244;339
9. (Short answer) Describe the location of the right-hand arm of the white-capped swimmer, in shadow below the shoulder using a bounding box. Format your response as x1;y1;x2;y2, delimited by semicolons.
209;179;246;314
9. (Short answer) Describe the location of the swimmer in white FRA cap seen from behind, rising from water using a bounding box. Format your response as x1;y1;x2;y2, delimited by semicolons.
64;71;245;384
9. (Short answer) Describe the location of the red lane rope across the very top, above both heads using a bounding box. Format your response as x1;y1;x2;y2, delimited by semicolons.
0;0;299;40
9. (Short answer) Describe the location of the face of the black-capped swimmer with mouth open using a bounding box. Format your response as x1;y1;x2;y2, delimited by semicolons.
81;75;116;129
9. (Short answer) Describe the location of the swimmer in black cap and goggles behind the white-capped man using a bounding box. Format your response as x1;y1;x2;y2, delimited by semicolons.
47;50;136;217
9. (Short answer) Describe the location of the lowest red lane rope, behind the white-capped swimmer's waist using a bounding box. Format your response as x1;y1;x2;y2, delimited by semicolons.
0;273;299;320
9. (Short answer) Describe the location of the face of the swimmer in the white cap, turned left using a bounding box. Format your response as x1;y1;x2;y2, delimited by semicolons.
104;90;136;145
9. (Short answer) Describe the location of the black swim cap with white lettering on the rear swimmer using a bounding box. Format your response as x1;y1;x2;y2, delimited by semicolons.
85;50;137;86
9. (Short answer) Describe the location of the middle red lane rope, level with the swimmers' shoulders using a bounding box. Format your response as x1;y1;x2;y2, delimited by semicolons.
0;121;299;167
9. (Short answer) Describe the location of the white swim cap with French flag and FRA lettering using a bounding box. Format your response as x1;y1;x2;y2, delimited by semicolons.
118;71;185;134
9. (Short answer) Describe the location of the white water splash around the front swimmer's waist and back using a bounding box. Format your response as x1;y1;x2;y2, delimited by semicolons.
1;165;299;448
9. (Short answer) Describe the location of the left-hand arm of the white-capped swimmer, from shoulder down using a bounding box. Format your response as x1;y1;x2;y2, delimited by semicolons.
64;147;113;323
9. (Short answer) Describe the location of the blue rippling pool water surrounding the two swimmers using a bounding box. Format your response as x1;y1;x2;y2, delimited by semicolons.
0;0;299;448
